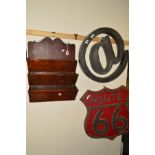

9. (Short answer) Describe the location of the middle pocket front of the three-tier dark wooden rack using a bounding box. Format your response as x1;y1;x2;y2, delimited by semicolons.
28;72;78;85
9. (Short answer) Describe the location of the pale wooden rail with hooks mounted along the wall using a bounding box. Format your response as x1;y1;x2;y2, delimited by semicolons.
26;29;129;45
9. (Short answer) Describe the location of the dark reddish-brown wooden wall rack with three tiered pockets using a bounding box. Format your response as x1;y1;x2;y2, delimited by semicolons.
27;37;78;102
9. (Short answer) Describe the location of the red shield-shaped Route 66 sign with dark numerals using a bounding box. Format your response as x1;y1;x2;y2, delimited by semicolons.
81;86;129;140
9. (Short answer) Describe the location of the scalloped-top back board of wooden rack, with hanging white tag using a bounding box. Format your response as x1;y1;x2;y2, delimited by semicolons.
28;37;75;60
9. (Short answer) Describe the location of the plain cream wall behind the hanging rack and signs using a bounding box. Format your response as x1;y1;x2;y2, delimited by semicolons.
27;0;129;155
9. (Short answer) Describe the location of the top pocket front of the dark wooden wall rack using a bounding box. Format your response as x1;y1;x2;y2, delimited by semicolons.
27;59;77;72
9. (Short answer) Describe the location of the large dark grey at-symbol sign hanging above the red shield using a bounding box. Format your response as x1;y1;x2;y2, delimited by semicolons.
79;27;129;82
